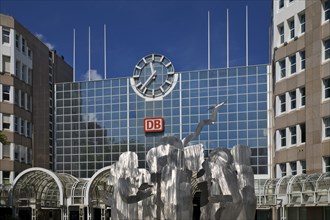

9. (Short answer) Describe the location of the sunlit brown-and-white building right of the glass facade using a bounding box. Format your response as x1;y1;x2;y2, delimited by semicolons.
271;0;330;219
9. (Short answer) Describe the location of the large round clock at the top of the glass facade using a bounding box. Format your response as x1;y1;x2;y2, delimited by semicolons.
131;54;178;100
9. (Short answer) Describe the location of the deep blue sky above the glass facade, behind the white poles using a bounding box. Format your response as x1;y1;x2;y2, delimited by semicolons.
0;0;272;81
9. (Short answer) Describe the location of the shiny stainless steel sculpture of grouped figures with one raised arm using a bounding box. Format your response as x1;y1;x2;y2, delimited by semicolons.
104;102;256;220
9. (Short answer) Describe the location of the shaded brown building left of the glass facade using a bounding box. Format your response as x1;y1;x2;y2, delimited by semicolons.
0;14;73;190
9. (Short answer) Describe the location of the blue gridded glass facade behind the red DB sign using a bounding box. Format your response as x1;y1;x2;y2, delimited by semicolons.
55;65;269;178
